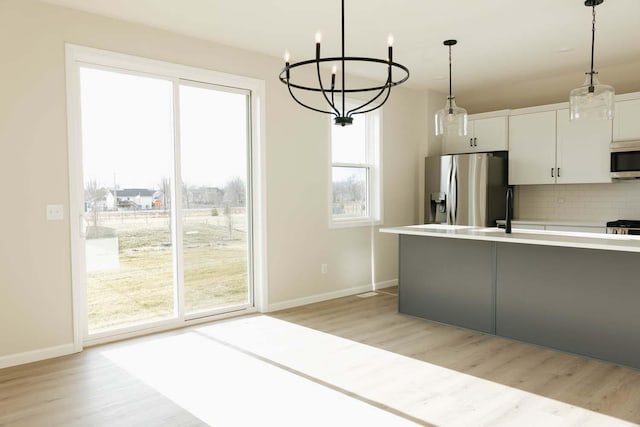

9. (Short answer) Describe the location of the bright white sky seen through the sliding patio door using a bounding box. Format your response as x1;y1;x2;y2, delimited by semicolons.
80;67;248;189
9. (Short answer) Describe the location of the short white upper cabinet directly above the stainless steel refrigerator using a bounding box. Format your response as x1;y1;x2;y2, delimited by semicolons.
442;111;509;154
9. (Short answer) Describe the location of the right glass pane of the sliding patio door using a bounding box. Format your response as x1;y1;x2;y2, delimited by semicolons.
180;85;249;315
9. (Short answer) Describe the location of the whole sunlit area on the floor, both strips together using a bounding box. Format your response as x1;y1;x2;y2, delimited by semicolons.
104;316;636;427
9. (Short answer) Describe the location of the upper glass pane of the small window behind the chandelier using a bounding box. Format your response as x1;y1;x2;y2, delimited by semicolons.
331;115;367;163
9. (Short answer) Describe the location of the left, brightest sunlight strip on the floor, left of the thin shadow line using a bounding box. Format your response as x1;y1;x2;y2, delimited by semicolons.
103;332;419;427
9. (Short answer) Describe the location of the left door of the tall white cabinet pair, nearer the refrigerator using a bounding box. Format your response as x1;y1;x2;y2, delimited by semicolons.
509;111;556;185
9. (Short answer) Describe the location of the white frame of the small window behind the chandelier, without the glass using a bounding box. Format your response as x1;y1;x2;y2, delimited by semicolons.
328;105;383;229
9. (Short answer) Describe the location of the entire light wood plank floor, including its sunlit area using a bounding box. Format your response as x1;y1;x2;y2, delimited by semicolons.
0;289;640;427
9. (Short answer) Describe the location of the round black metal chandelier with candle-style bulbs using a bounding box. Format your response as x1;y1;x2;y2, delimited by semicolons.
280;0;409;126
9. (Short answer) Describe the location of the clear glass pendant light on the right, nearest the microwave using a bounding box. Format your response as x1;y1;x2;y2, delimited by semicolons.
569;0;615;120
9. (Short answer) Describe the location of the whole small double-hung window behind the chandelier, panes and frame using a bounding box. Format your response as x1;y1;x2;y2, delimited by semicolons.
330;110;382;227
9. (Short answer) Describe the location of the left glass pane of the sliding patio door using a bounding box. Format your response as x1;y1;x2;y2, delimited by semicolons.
80;68;175;334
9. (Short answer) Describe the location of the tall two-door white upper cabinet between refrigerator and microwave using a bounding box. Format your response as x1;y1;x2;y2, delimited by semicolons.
509;108;612;185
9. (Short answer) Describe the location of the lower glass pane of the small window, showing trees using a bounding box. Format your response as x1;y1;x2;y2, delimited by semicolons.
331;166;369;220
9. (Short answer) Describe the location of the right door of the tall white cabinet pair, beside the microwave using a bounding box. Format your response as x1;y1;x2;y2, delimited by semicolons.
556;109;612;184
